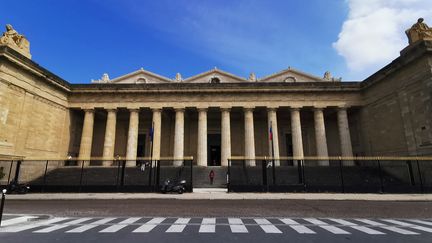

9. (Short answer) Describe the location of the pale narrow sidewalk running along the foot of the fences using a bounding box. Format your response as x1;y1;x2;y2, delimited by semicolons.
6;189;432;201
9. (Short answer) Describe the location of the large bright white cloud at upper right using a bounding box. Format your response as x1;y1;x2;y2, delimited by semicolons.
333;0;432;78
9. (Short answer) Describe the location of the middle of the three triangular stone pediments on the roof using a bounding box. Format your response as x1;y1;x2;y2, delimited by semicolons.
183;68;248;83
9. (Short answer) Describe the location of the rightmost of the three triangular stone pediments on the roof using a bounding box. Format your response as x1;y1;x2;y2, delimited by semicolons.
259;67;326;83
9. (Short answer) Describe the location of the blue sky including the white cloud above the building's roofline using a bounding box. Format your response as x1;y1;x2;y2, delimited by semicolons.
0;0;432;83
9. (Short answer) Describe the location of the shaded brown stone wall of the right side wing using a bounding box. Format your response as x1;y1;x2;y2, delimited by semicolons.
360;42;432;156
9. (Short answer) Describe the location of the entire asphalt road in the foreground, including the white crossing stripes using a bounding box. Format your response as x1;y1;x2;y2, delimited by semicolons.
0;199;432;243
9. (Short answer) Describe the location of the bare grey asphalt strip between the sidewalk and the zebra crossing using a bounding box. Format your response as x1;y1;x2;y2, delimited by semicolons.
5;199;432;218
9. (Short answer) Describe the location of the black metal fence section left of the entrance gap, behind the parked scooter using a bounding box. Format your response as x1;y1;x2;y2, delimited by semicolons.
0;159;193;192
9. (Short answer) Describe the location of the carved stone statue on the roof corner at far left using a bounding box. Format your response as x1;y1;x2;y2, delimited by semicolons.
0;24;31;58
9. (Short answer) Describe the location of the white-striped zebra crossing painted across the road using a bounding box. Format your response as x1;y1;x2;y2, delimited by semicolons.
0;216;432;235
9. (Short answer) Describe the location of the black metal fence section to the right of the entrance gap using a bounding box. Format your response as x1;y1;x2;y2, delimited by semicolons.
228;158;432;193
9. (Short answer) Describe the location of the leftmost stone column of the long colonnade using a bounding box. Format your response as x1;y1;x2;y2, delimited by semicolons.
78;109;94;165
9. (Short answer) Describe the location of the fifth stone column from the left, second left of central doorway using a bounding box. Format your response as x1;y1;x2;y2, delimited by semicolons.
174;108;184;166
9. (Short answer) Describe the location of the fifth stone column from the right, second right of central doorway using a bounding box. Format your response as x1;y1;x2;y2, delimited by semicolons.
244;108;256;166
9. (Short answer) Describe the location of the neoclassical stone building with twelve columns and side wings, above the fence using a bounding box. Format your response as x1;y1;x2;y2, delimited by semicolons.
0;20;432;171
